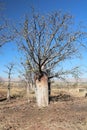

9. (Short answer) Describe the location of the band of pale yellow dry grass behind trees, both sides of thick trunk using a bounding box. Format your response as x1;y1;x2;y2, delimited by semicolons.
0;83;87;98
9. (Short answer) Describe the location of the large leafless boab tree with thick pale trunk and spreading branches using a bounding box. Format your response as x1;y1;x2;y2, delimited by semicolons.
16;11;85;107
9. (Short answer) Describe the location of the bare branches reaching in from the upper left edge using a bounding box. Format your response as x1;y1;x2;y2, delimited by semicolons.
0;2;16;47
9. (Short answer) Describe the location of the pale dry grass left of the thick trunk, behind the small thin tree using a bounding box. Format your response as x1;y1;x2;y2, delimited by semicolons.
0;83;35;99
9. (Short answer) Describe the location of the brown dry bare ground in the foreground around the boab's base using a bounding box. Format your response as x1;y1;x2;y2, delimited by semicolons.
0;85;87;130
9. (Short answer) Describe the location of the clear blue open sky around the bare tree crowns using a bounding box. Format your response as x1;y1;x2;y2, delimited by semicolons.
0;0;87;78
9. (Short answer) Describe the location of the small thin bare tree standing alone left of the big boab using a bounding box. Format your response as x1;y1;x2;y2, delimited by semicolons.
5;63;14;101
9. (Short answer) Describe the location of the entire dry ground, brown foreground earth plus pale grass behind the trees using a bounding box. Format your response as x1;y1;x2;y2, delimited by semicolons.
0;84;87;130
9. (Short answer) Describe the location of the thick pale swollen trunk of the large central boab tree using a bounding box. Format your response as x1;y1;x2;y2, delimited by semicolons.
36;74;49;107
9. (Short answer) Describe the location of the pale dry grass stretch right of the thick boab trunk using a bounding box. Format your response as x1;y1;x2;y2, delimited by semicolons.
51;83;87;97
